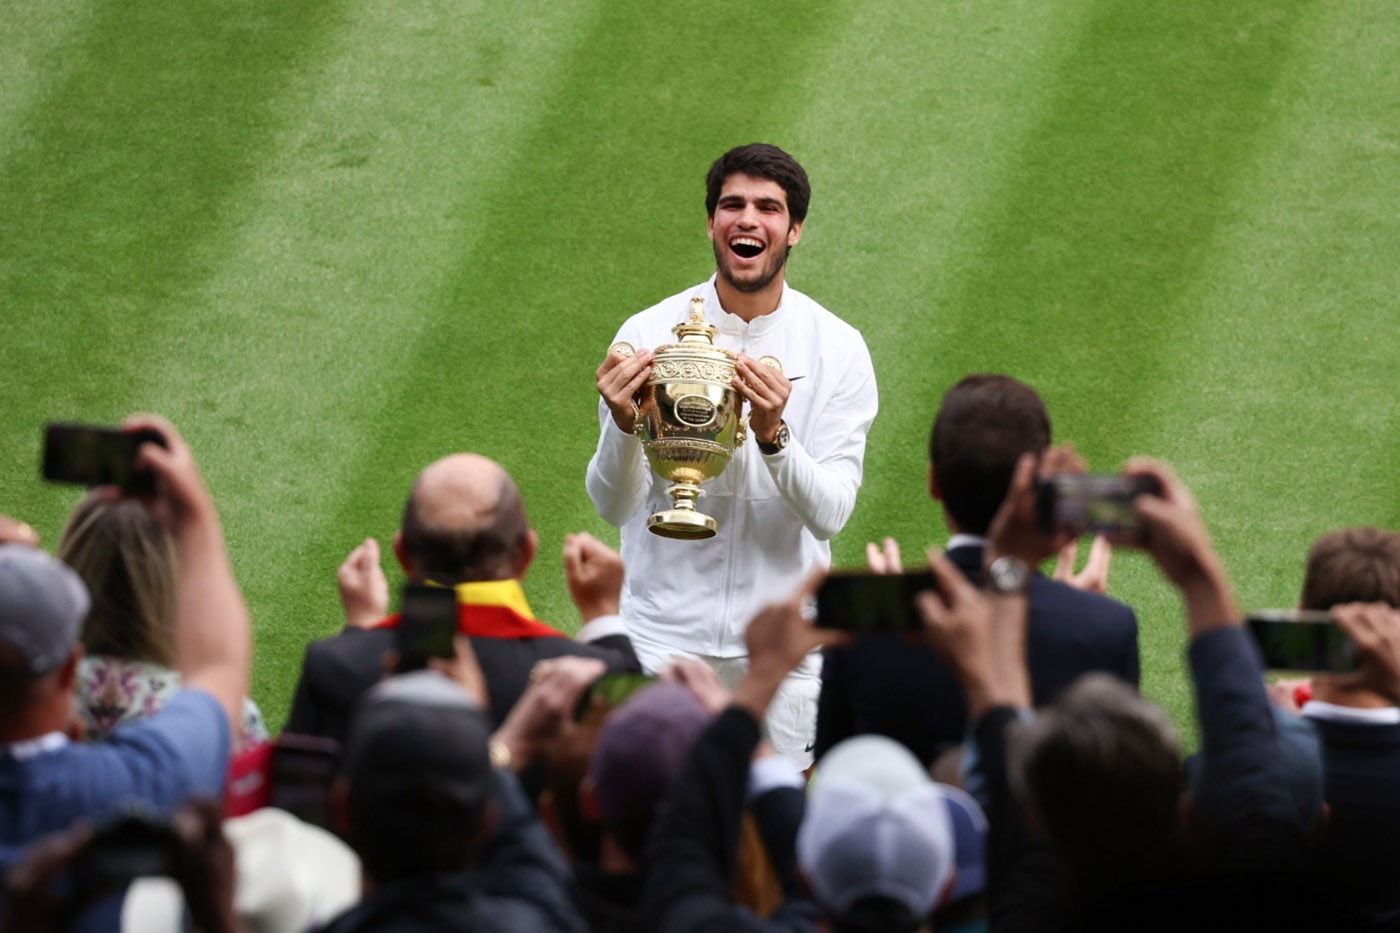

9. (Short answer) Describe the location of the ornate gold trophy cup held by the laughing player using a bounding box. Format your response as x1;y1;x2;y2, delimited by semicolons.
610;297;783;541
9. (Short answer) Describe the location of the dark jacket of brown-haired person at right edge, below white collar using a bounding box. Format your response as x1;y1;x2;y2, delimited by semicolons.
1308;717;1400;930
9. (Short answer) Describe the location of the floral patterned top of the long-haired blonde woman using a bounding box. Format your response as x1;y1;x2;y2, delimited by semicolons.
73;654;267;755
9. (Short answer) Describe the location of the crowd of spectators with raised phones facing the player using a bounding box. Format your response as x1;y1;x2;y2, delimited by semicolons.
0;375;1400;933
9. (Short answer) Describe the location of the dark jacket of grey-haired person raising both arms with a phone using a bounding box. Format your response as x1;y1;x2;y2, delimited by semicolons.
974;626;1321;933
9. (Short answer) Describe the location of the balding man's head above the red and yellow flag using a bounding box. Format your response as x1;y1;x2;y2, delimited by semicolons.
400;454;533;583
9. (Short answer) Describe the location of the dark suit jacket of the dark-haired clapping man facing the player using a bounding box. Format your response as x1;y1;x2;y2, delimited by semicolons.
815;537;1140;763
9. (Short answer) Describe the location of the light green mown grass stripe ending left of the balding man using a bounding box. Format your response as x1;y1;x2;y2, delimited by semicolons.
127;1;613;721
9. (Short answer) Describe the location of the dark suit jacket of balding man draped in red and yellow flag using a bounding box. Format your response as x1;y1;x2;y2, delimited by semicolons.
286;613;641;742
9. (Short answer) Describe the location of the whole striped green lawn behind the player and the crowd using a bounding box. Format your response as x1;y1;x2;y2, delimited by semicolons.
0;0;1400;724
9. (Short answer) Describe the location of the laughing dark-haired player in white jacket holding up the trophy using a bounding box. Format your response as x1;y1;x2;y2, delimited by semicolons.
587;143;878;765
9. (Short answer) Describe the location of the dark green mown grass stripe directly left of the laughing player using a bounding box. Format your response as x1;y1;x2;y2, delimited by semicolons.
302;3;856;683
